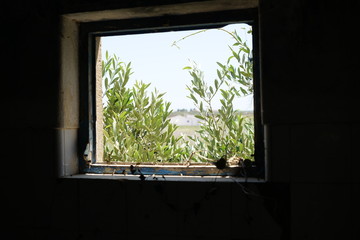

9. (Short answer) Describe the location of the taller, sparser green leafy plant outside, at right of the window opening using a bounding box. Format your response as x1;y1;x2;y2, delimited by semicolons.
182;29;254;161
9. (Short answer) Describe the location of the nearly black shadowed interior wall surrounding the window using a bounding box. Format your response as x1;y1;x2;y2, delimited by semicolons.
0;0;360;239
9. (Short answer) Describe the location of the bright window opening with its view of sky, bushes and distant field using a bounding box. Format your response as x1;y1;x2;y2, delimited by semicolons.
85;23;262;177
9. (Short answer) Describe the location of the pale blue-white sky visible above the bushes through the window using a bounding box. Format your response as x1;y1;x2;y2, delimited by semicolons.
101;24;253;111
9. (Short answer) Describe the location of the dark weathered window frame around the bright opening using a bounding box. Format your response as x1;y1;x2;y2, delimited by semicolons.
62;1;267;181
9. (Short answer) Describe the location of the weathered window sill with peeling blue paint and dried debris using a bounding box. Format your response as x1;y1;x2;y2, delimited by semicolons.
70;163;266;182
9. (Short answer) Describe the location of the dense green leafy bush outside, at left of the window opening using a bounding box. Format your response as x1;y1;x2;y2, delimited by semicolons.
102;53;181;162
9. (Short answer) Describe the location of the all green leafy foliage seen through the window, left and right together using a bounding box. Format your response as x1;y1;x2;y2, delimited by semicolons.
102;26;254;163
